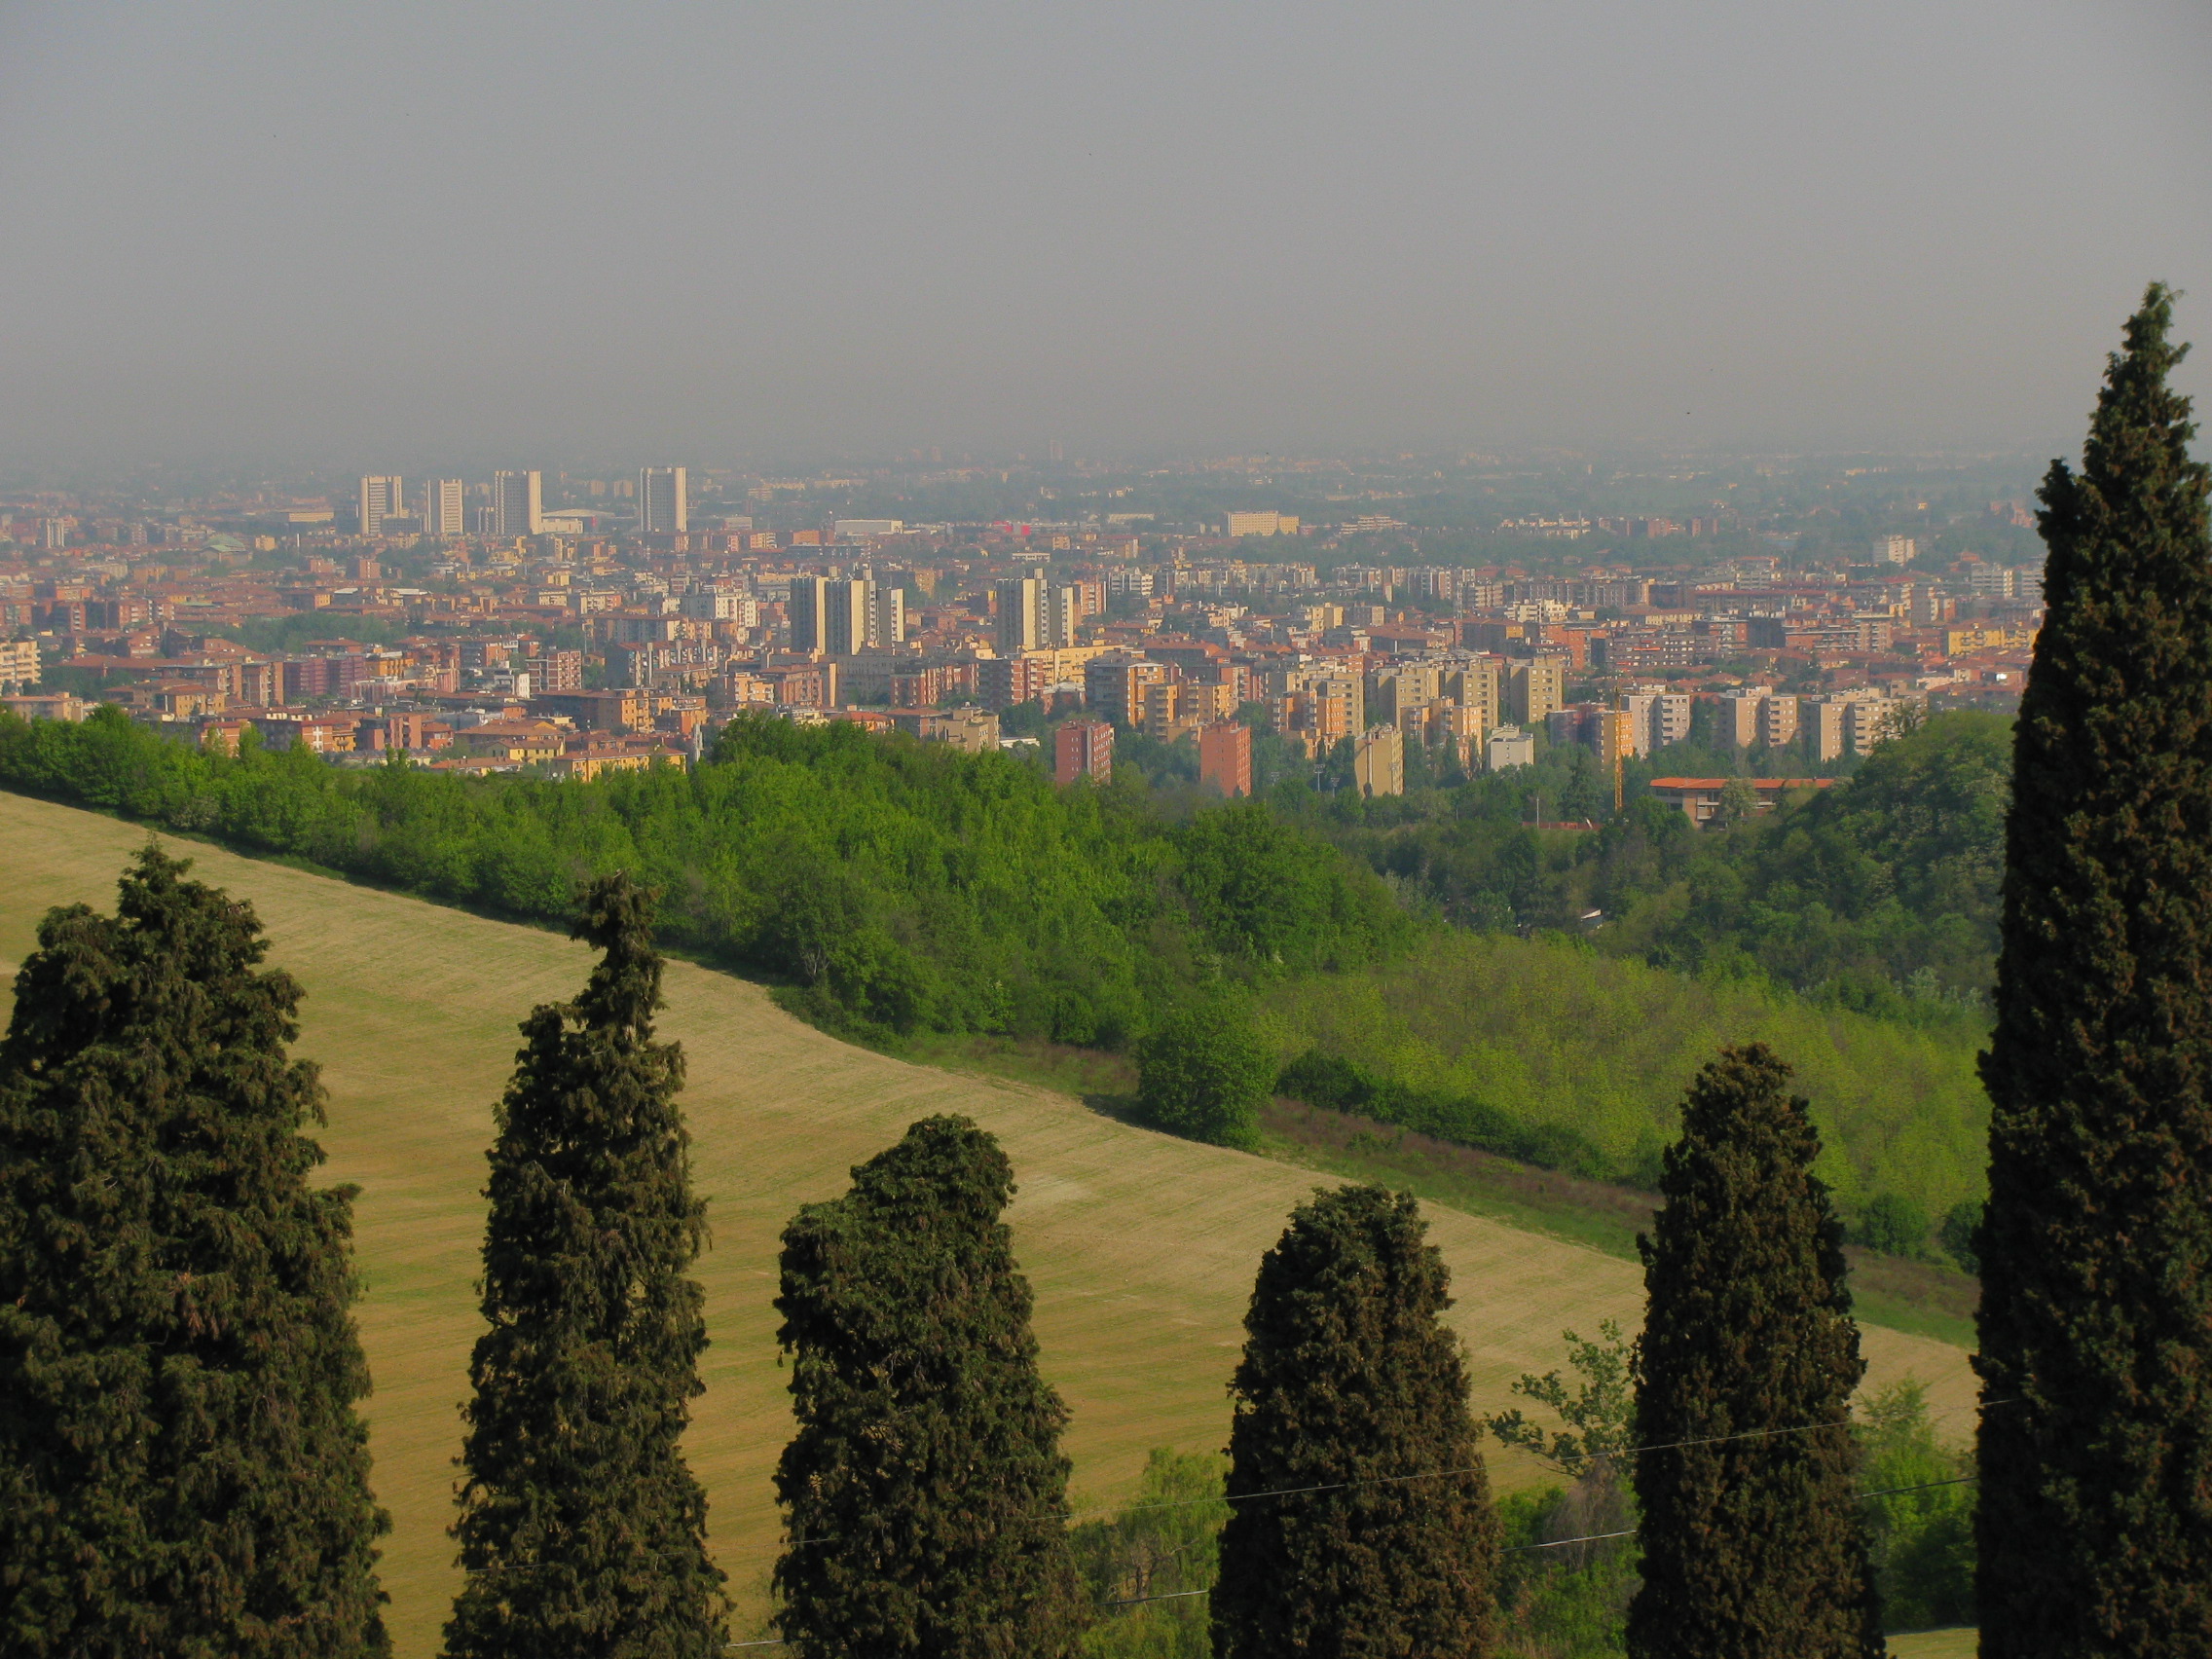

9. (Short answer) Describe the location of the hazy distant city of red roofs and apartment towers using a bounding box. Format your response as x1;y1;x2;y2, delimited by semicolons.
0;451;2042;819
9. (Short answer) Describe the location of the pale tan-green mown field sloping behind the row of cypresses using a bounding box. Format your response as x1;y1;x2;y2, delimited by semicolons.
0;796;1971;1659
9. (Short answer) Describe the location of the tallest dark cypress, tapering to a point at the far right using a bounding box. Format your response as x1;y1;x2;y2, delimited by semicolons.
1977;285;2212;1659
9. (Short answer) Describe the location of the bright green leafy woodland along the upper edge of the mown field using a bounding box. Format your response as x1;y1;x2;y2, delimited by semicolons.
0;710;1416;1047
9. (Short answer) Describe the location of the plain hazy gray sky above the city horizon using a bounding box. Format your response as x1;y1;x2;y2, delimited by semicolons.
0;0;2212;466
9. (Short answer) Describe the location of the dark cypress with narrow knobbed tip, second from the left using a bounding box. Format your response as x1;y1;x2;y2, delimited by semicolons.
445;873;725;1659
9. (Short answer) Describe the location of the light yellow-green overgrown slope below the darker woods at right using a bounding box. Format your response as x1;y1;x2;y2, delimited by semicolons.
1266;934;1989;1217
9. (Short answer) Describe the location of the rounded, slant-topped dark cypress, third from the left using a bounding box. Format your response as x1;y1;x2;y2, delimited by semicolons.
776;1117;1084;1659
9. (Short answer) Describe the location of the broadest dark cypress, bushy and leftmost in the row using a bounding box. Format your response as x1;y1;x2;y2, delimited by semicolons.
0;847;389;1659
